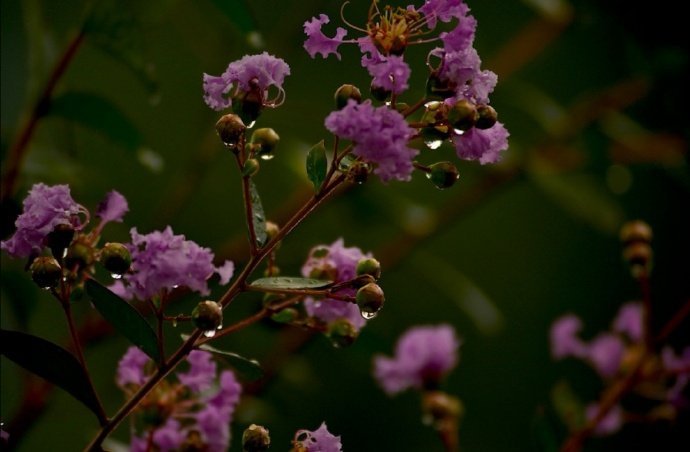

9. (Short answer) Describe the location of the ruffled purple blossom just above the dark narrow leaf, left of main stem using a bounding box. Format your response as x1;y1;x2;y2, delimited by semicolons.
113;226;234;300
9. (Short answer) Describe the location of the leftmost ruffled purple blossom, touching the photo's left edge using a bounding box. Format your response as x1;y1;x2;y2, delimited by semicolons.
0;183;88;257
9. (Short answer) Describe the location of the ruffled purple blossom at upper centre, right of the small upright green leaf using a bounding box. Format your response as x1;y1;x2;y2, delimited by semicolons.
325;100;419;182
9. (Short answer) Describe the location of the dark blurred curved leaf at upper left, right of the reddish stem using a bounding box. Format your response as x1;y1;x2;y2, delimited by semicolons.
50;92;142;152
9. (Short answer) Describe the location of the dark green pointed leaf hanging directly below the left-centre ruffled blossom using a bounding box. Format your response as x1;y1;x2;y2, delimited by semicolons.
85;279;161;363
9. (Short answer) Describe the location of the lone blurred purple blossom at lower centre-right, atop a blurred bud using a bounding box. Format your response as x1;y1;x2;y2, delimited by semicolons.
374;325;460;395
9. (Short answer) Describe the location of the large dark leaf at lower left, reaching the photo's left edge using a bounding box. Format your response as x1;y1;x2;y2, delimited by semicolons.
0;330;105;423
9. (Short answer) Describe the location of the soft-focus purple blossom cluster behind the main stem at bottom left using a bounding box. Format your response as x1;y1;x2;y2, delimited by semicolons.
116;347;242;452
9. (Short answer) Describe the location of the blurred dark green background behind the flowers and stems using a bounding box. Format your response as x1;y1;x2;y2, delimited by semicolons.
0;0;690;451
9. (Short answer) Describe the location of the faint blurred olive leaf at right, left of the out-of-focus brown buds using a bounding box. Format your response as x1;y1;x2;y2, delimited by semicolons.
529;172;624;235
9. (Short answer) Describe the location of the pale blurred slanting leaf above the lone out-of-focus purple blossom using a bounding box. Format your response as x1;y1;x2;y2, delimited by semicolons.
412;252;503;334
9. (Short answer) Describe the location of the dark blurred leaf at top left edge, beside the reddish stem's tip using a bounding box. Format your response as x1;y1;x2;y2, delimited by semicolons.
83;0;158;96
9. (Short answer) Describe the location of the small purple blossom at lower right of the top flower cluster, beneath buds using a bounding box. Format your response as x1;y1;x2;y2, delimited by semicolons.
453;122;510;165
